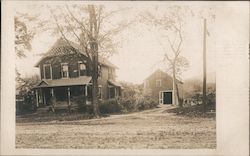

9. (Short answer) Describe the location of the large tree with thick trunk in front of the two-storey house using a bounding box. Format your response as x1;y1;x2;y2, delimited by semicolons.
45;5;131;117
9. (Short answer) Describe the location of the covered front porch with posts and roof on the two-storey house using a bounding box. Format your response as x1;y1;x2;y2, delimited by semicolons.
33;76;92;111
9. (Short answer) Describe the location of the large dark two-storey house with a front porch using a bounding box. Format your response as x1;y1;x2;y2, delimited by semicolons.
34;38;121;107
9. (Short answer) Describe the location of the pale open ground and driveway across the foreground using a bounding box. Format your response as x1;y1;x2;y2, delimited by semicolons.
16;106;216;149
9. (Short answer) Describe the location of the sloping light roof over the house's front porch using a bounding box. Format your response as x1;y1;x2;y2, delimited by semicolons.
34;76;91;88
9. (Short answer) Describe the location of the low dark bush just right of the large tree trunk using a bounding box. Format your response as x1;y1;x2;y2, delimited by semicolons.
99;99;122;114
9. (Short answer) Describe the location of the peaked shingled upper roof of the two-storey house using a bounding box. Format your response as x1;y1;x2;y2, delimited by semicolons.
35;38;118;69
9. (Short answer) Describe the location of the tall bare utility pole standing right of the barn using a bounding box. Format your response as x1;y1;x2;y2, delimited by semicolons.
202;19;207;112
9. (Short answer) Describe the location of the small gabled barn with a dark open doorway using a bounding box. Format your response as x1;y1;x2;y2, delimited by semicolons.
143;69;183;104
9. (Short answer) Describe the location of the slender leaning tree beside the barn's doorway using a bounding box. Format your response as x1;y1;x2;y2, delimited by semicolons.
142;6;192;107
